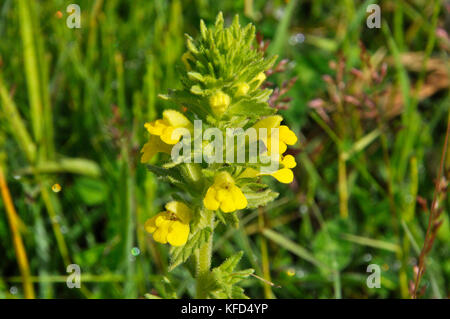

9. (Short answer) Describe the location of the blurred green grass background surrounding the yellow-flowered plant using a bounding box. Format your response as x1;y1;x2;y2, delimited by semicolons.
0;0;450;298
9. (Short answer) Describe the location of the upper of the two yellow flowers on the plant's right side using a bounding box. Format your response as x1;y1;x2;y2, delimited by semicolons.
253;115;297;154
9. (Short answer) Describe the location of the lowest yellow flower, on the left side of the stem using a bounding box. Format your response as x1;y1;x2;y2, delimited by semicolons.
144;201;192;246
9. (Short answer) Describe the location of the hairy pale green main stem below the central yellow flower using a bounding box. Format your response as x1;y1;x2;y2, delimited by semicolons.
196;210;214;299
